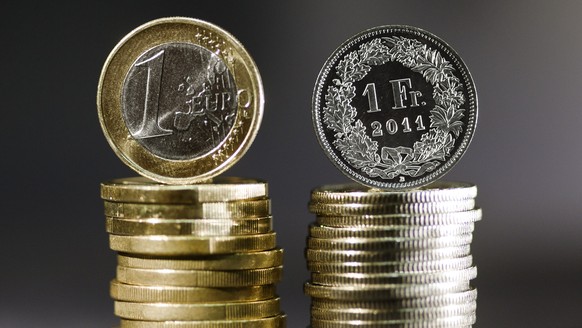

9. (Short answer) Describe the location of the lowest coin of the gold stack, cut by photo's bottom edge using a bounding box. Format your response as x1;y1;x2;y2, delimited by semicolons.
120;313;287;328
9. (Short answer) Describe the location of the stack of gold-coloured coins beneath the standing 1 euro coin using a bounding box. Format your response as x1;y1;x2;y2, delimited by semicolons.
101;177;286;328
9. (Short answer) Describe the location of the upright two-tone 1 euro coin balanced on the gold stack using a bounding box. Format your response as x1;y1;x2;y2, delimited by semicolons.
97;17;264;184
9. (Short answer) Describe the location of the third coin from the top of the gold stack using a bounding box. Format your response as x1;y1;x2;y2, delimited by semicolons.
105;217;273;237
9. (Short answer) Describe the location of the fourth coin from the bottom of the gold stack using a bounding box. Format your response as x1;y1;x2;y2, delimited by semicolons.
117;266;283;287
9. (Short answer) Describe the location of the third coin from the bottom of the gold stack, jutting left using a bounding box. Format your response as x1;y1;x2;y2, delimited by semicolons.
110;280;276;304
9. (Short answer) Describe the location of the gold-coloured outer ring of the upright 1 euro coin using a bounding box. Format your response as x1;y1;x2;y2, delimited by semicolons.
97;17;264;184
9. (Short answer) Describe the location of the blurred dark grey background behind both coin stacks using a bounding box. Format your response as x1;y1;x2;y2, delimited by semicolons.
0;0;582;328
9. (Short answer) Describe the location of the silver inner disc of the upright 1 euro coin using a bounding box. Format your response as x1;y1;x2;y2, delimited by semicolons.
122;42;237;160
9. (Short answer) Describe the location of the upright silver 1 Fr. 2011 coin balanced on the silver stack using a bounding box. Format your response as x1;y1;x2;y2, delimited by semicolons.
312;26;477;190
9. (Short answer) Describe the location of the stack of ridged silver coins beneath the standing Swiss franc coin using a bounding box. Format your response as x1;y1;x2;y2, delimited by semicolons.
305;182;481;328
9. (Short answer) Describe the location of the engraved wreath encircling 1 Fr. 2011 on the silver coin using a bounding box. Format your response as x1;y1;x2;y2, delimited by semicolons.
323;37;465;181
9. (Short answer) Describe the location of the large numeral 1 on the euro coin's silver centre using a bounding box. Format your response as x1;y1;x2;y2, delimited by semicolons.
132;50;172;139
